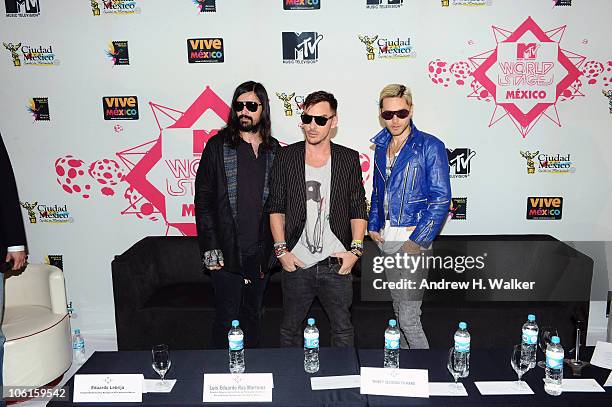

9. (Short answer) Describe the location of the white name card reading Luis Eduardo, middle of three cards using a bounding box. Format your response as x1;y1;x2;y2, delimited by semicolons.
202;373;274;403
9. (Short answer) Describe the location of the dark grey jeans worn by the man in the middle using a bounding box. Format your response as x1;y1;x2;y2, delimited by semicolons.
280;265;354;347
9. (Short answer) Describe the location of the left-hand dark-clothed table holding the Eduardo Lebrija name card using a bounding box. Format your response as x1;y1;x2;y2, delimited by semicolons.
47;348;367;407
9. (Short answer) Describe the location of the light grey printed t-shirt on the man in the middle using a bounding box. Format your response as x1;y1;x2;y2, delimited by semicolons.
291;158;346;268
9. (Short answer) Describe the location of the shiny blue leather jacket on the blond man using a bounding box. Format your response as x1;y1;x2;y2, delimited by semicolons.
368;123;451;247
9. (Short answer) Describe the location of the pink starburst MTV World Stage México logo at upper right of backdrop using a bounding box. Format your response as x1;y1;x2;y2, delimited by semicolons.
428;17;612;138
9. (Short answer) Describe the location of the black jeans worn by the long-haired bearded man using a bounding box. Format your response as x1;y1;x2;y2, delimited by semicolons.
211;256;269;349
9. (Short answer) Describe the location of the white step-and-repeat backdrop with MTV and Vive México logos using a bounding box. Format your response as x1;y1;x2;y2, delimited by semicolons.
0;0;612;331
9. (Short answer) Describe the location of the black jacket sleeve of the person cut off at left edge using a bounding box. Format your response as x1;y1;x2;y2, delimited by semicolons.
0;135;26;263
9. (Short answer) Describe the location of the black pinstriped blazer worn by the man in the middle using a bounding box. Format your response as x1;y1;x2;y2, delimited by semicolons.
266;141;368;250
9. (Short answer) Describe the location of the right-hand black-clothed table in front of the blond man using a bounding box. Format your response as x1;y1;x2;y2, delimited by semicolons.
358;347;612;407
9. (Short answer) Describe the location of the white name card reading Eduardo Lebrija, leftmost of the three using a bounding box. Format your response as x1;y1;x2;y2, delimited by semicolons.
73;374;144;403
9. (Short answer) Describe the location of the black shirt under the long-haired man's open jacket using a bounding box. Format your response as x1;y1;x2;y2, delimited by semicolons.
236;140;267;255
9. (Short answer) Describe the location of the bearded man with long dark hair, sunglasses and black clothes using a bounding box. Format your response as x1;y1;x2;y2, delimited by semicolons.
195;81;279;348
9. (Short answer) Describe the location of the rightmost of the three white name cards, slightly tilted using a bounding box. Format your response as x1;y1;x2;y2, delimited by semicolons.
361;367;429;397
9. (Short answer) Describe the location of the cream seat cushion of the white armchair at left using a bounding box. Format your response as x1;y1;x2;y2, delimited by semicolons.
2;305;67;342
